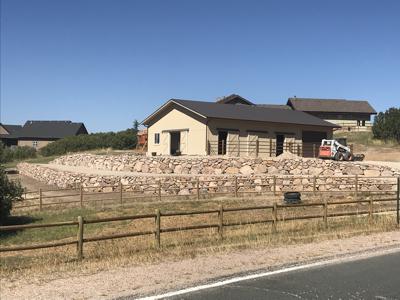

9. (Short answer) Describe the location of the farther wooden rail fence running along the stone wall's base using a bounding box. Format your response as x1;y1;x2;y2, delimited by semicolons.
13;175;397;211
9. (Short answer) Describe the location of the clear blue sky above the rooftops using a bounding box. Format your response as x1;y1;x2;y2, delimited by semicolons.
1;0;400;132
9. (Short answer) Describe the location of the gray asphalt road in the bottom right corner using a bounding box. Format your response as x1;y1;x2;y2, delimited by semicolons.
169;252;400;300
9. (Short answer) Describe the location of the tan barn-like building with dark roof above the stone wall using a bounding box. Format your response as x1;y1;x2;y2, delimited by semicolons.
142;95;339;157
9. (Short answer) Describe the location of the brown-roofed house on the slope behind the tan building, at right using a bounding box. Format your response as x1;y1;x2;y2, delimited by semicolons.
287;97;376;131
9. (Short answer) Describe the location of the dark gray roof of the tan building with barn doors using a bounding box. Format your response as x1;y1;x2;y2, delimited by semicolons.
143;99;340;128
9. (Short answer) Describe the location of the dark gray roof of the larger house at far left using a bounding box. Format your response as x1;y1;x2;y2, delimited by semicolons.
18;121;87;139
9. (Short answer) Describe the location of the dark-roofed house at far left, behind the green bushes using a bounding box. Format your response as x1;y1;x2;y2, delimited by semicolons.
0;121;88;149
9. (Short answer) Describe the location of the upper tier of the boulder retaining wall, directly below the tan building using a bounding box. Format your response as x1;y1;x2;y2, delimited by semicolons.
52;153;399;176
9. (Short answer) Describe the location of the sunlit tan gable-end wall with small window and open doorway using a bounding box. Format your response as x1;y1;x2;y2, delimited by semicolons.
147;105;206;155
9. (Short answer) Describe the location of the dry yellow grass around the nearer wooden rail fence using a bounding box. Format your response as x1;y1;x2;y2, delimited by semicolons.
0;198;395;278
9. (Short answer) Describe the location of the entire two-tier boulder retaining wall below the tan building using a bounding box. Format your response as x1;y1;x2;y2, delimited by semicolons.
18;154;400;195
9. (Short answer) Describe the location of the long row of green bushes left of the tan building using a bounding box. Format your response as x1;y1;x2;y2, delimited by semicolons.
40;129;137;156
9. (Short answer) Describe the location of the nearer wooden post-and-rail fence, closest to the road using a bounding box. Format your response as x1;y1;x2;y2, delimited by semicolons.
0;191;400;259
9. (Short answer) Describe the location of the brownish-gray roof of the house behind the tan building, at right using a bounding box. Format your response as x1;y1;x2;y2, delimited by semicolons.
287;98;376;114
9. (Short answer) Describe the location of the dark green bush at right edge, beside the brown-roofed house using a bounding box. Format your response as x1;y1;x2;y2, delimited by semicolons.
372;107;400;144
